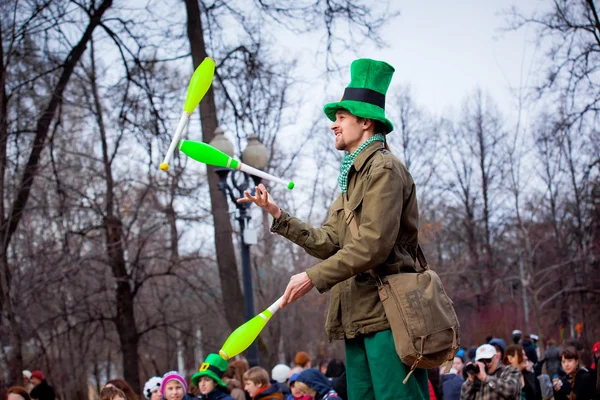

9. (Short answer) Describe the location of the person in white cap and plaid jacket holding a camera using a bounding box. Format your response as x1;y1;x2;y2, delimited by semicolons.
460;344;522;400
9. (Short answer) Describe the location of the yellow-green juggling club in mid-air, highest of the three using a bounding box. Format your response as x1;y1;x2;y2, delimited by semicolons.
160;57;215;171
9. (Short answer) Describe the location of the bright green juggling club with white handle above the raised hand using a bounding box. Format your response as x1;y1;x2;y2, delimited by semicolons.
179;140;294;190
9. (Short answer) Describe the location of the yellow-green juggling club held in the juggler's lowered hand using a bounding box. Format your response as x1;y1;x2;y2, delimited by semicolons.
219;296;283;360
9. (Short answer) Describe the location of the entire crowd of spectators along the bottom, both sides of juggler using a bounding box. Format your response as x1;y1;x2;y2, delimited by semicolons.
7;330;600;400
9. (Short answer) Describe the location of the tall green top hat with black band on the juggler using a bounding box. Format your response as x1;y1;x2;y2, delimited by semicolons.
323;58;394;133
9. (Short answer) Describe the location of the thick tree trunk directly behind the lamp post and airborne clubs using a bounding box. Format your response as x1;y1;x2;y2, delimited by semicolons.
185;0;246;330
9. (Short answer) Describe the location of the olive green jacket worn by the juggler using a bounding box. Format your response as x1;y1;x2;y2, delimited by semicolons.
271;142;419;340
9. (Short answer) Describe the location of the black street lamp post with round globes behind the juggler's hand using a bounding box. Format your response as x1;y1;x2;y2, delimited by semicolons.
210;127;269;367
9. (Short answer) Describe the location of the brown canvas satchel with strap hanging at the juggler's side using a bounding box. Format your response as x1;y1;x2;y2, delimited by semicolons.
343;196;460;383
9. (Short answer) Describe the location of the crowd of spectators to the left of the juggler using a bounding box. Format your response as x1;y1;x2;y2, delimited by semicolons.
7;351;346;400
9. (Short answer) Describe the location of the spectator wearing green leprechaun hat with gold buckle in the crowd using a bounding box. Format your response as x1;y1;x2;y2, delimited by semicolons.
192;353;234;400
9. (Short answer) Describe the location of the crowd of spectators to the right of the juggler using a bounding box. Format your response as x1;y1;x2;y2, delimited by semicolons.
429;330;600;400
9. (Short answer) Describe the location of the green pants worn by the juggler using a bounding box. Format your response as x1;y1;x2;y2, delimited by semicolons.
344;329;429;400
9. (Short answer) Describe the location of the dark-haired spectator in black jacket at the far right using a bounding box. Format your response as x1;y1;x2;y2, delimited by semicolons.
554;349;596;400
